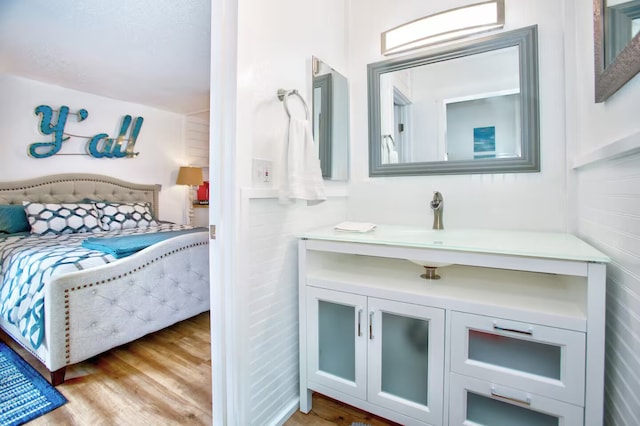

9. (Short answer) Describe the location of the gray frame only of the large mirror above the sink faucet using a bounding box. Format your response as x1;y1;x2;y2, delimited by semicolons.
367;25;540;177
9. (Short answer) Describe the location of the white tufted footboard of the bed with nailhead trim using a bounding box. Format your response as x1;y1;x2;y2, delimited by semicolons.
35;232;209;382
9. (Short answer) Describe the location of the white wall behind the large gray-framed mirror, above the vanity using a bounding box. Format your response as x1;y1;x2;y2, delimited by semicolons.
349;0;566;231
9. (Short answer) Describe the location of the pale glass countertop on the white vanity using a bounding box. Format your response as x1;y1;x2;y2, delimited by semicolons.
299;225;610;263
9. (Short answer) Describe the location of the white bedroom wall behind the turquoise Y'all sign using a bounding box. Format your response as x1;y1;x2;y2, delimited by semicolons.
0;74;186;222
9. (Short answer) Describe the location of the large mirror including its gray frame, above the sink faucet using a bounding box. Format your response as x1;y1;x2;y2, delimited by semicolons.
368;26;540;176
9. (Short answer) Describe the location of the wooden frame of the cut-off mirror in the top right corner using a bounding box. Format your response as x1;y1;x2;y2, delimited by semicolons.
593;0;640;103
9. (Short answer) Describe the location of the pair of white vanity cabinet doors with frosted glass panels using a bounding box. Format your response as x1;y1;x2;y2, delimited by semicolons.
306;286;444;424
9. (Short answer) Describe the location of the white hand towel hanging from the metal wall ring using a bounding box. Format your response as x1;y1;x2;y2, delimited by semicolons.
279;117;327;205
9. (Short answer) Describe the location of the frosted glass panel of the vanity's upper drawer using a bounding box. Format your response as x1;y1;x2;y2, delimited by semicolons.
469;330;562;380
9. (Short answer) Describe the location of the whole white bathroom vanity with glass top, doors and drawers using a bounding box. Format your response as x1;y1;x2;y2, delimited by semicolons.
299;225;608;426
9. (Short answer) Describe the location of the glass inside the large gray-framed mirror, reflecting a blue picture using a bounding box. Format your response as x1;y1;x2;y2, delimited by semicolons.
380;46;522;164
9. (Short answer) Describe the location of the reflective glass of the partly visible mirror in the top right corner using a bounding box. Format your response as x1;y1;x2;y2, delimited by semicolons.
604;0;640;67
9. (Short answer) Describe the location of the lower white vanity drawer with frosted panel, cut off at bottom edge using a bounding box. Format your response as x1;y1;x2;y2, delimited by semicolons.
449;373;584;426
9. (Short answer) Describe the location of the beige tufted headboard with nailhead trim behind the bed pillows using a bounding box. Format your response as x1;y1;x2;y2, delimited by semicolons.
0;173;161;217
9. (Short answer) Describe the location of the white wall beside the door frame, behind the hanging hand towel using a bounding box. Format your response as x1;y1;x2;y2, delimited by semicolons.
231;0;349;425
